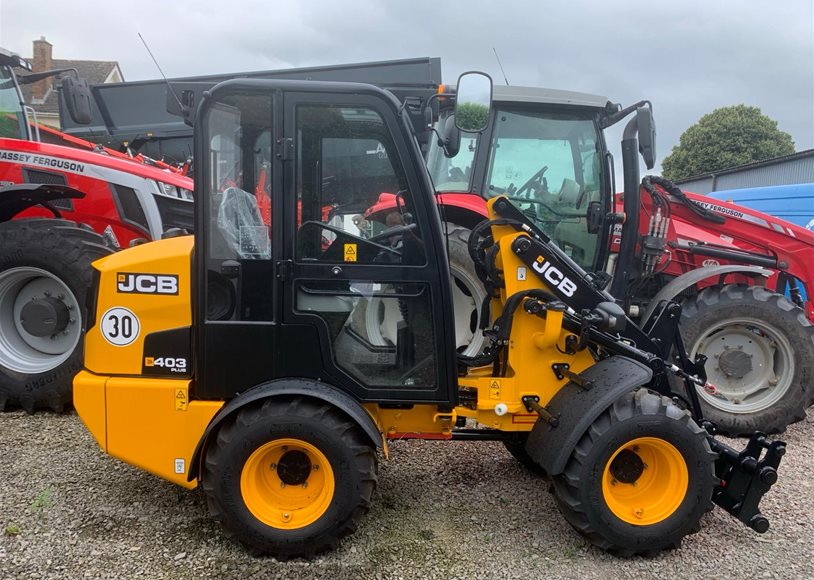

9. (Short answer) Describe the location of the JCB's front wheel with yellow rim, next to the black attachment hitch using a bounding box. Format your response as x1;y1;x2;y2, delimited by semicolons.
553;389;715;556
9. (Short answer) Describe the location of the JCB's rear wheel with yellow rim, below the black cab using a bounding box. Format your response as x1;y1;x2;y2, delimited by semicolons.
203;398;377;560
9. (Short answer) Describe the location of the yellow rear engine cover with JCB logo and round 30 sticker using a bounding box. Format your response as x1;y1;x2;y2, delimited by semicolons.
74;236;223;488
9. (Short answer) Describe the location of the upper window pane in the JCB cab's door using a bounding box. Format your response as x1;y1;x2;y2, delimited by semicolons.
295;105;425;265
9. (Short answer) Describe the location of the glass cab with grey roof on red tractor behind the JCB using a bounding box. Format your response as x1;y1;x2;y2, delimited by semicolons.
427;86;612;271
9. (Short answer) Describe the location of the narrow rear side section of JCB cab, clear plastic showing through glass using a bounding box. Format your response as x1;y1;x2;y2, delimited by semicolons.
193;87;282;399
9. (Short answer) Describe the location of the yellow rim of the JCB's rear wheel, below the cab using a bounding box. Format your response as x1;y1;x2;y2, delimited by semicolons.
240;439;335;530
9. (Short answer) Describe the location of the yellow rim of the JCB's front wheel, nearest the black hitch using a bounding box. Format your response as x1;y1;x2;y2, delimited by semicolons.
602;437;689;526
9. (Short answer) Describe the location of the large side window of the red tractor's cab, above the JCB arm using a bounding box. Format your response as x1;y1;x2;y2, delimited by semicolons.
486;110;601;269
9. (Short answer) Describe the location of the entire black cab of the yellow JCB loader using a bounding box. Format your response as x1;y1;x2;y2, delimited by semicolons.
193;80;478;404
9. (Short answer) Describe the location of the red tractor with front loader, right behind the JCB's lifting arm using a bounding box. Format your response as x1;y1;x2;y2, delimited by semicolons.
363;86;814;435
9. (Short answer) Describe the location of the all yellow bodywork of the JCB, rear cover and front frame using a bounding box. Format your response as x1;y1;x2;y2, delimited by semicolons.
74;200;594;487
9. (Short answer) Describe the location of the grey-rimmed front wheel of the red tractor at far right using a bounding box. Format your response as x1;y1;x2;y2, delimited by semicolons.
681;285;814;435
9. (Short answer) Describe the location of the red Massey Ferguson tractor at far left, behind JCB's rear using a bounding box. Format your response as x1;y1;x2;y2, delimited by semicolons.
0;49;193;412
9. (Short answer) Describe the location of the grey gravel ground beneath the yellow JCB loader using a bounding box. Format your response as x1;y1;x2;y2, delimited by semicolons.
0;412;814;580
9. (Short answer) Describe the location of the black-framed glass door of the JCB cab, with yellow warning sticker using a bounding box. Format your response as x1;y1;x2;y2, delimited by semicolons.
282;90;457;403
